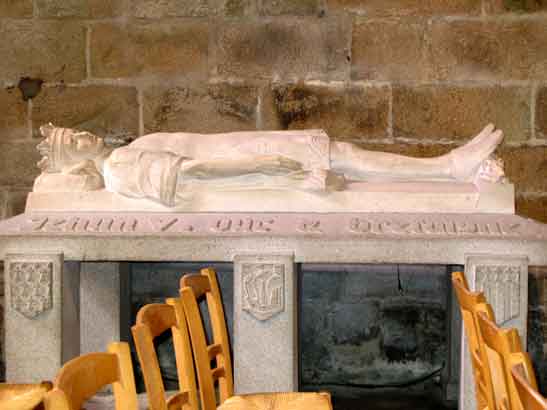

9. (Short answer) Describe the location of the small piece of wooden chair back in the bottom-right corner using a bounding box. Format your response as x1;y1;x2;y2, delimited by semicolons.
511;362;547;410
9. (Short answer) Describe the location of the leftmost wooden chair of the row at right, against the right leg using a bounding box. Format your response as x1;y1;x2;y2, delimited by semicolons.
452;272;495;410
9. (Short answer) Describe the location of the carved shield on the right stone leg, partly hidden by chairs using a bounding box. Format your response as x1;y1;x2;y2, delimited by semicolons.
476;265;521;324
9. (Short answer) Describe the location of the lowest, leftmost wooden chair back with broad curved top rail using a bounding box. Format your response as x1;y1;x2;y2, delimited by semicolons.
44;342;138;410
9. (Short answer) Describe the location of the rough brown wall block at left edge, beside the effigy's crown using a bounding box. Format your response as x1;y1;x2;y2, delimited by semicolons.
0;142;40;186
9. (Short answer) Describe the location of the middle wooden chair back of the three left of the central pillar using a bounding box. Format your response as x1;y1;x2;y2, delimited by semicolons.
131;299;198;410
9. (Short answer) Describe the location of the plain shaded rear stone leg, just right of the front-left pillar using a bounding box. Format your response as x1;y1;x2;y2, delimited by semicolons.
80;262;121;353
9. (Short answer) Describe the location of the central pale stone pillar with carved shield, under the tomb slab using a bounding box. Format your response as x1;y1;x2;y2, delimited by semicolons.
233;254;298;394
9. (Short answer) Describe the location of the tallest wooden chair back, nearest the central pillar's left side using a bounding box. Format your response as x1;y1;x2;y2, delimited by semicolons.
180;269;234;410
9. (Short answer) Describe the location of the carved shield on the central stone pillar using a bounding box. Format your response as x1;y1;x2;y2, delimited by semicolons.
241;263;285;320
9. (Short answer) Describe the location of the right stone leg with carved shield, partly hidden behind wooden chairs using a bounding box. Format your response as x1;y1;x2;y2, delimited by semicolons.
459;253;529;410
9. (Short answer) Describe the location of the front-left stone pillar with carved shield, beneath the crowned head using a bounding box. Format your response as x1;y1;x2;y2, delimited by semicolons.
5;253;79;383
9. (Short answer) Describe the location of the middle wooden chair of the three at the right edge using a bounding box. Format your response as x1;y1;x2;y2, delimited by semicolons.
478;309;537;410
